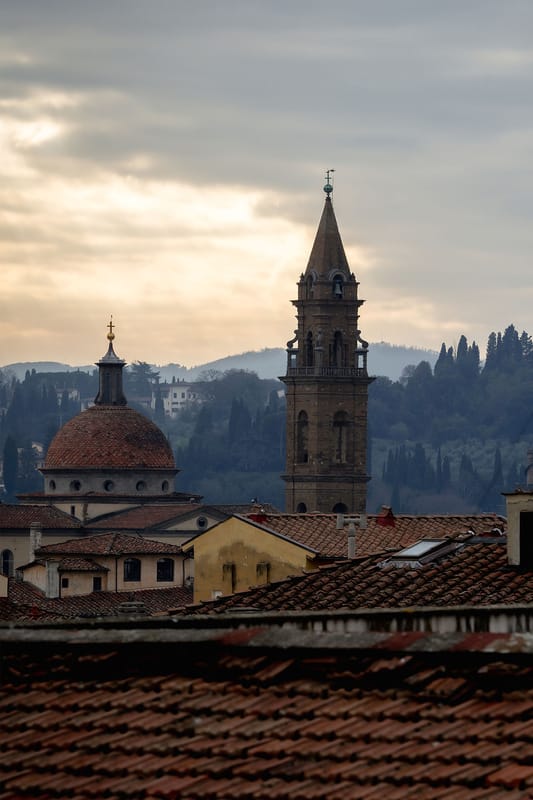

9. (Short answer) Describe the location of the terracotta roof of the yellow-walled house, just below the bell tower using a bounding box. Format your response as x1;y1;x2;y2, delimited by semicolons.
243;512;506;558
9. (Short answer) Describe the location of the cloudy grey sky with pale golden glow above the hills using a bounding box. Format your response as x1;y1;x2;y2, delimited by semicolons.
0;0;533;369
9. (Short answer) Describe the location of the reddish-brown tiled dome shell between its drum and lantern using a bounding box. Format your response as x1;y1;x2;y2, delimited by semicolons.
44;405;176;470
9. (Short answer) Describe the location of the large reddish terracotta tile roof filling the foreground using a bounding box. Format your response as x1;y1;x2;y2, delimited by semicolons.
0;629;533;800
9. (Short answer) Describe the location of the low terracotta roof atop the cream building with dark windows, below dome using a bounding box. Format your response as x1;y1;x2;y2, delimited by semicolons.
36;532;181;557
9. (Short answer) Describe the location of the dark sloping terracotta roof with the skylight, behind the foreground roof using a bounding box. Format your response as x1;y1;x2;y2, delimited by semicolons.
196;537;533;613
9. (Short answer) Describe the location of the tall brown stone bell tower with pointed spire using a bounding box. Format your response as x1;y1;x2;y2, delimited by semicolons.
280;170;373;513
